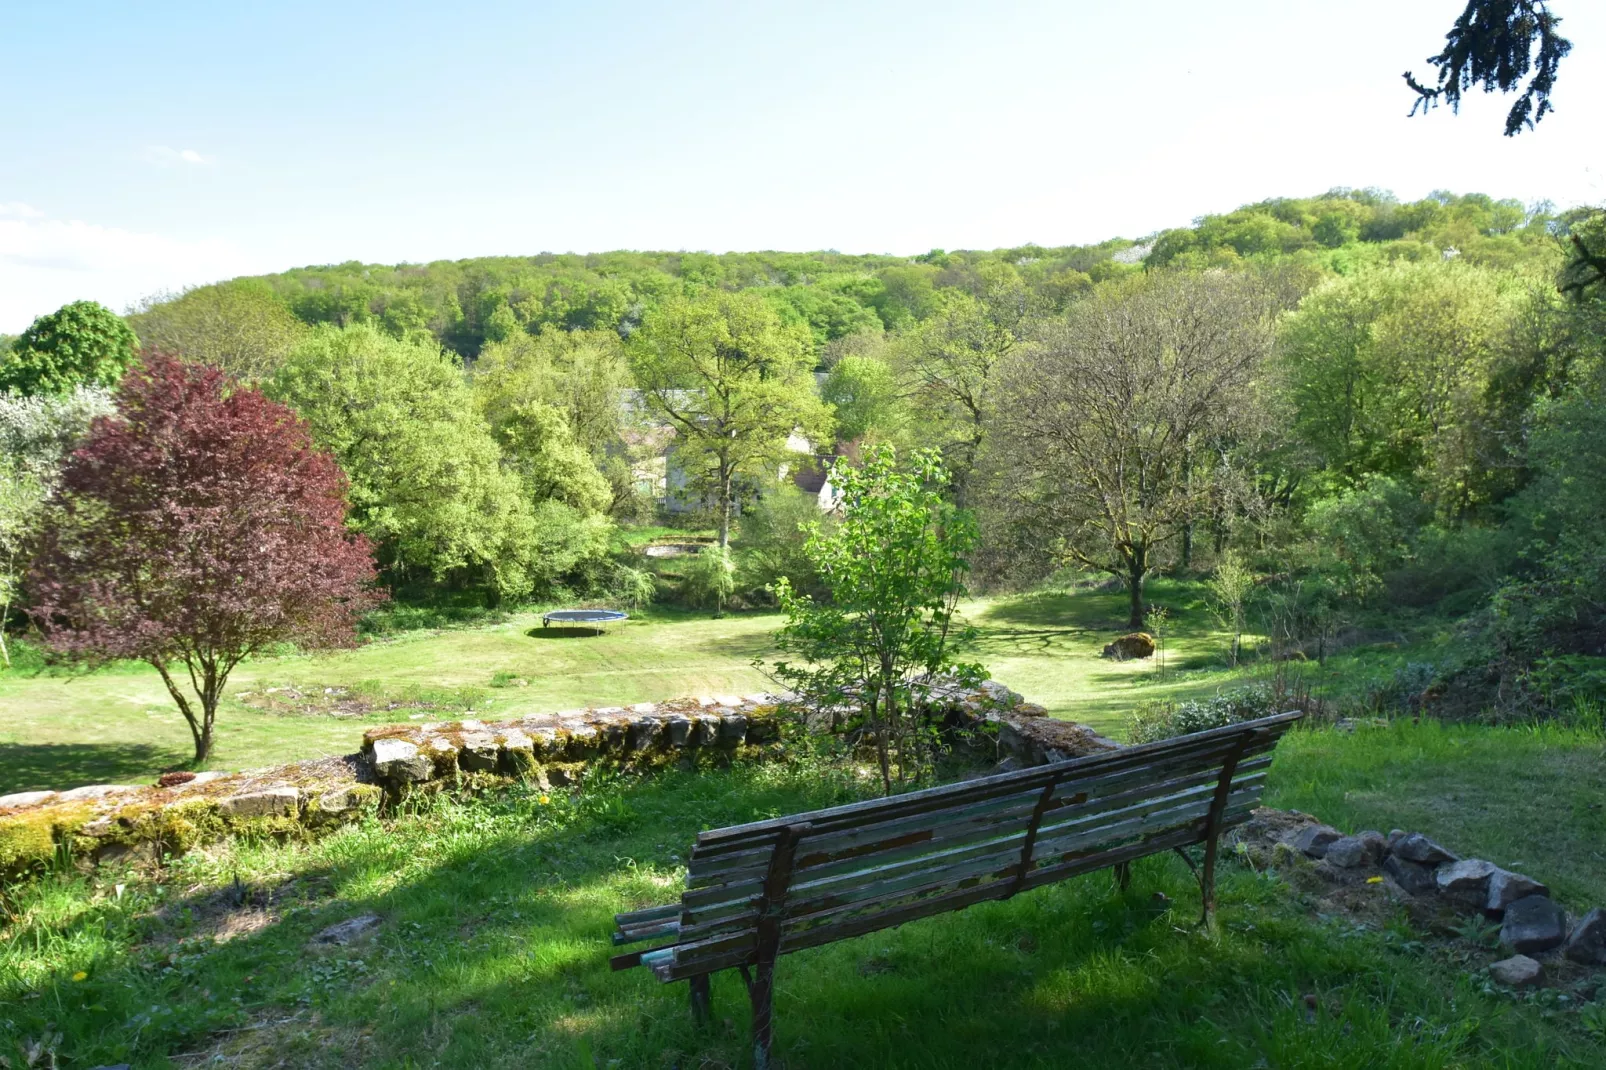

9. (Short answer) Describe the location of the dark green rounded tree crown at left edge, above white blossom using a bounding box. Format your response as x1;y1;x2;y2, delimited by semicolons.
0;300;140;397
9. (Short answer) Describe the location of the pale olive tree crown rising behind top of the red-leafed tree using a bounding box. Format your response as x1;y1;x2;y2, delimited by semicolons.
130;280;307;382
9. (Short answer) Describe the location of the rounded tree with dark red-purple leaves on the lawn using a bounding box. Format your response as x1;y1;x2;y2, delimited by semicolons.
29;355;384;762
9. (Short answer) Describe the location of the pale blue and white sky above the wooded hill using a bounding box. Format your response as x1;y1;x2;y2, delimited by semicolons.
0;0;1606;331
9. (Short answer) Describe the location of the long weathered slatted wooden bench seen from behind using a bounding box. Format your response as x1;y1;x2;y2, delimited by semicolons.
612;703;1299;1067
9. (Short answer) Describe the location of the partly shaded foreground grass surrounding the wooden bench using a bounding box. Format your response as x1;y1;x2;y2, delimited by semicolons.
0;742;1606;1070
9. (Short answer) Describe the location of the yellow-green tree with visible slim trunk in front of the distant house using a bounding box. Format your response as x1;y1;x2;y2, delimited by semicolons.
631;292;830;546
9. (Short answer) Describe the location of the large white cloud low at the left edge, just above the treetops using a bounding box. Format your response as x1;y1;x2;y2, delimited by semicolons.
0;202;260;334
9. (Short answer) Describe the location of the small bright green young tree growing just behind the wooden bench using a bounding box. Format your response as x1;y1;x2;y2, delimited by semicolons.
772;447;981;794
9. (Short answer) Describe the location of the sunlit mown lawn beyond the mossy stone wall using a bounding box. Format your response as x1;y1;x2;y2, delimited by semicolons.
0;582;1252;794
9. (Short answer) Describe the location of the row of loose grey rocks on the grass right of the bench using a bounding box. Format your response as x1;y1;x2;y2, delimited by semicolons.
1240;810;1606;985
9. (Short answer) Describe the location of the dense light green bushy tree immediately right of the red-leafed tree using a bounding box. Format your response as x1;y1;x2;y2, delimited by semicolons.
268;326;549;599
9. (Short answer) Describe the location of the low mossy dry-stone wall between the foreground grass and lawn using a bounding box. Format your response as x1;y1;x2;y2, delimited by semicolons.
0;681;1118;879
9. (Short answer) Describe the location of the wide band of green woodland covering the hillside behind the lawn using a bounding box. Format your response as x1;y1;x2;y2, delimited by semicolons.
0;190;1606;713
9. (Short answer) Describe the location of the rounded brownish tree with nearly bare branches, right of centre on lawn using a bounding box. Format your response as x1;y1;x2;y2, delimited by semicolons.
993;273;1272;628
